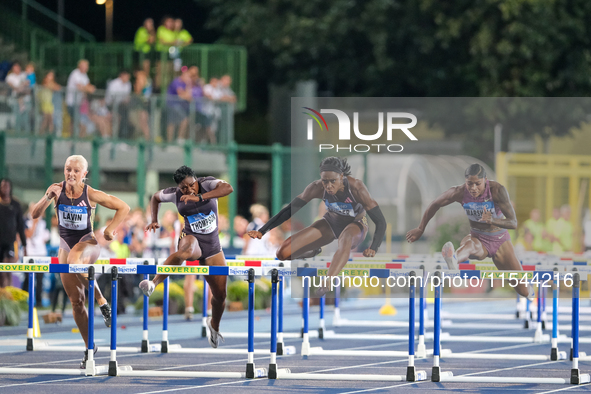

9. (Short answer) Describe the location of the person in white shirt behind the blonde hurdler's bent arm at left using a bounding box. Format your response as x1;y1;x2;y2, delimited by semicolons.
22;202;49;307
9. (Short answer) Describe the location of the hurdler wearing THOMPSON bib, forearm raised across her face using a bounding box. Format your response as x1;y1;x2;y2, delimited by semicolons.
140;166;234;348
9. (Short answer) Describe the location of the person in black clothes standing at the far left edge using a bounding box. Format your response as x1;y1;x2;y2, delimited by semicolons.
0;178;27;287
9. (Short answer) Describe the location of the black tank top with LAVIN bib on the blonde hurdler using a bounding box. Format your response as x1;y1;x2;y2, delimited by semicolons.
57;181;94;241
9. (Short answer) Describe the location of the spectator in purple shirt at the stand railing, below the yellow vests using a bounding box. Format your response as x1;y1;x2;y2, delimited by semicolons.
166;71;193;143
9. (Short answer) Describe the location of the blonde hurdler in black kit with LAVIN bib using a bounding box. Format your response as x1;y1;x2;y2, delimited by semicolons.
31;155;129;368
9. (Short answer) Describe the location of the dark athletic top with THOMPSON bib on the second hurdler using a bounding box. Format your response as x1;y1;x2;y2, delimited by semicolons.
159;176;220;235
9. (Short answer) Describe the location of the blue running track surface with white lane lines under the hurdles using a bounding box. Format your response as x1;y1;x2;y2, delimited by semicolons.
0;298;591;394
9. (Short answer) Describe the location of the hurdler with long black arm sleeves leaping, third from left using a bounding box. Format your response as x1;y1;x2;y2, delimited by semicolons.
248;157;386;296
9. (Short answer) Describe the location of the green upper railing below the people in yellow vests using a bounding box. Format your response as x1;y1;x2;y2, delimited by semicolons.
39;43;246;111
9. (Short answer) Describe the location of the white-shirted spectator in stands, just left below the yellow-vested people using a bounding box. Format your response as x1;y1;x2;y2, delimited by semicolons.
105;70;131;138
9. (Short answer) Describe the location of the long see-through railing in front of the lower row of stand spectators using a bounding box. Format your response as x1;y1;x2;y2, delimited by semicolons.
0;81;234;145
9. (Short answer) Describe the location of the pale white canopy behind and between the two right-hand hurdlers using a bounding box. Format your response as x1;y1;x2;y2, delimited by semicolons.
347;154;495;235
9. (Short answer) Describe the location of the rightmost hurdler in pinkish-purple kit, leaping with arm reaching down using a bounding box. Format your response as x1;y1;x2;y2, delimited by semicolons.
406;164;533;297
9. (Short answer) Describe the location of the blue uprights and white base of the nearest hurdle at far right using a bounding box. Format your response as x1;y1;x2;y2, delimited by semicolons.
431;271;591;384
